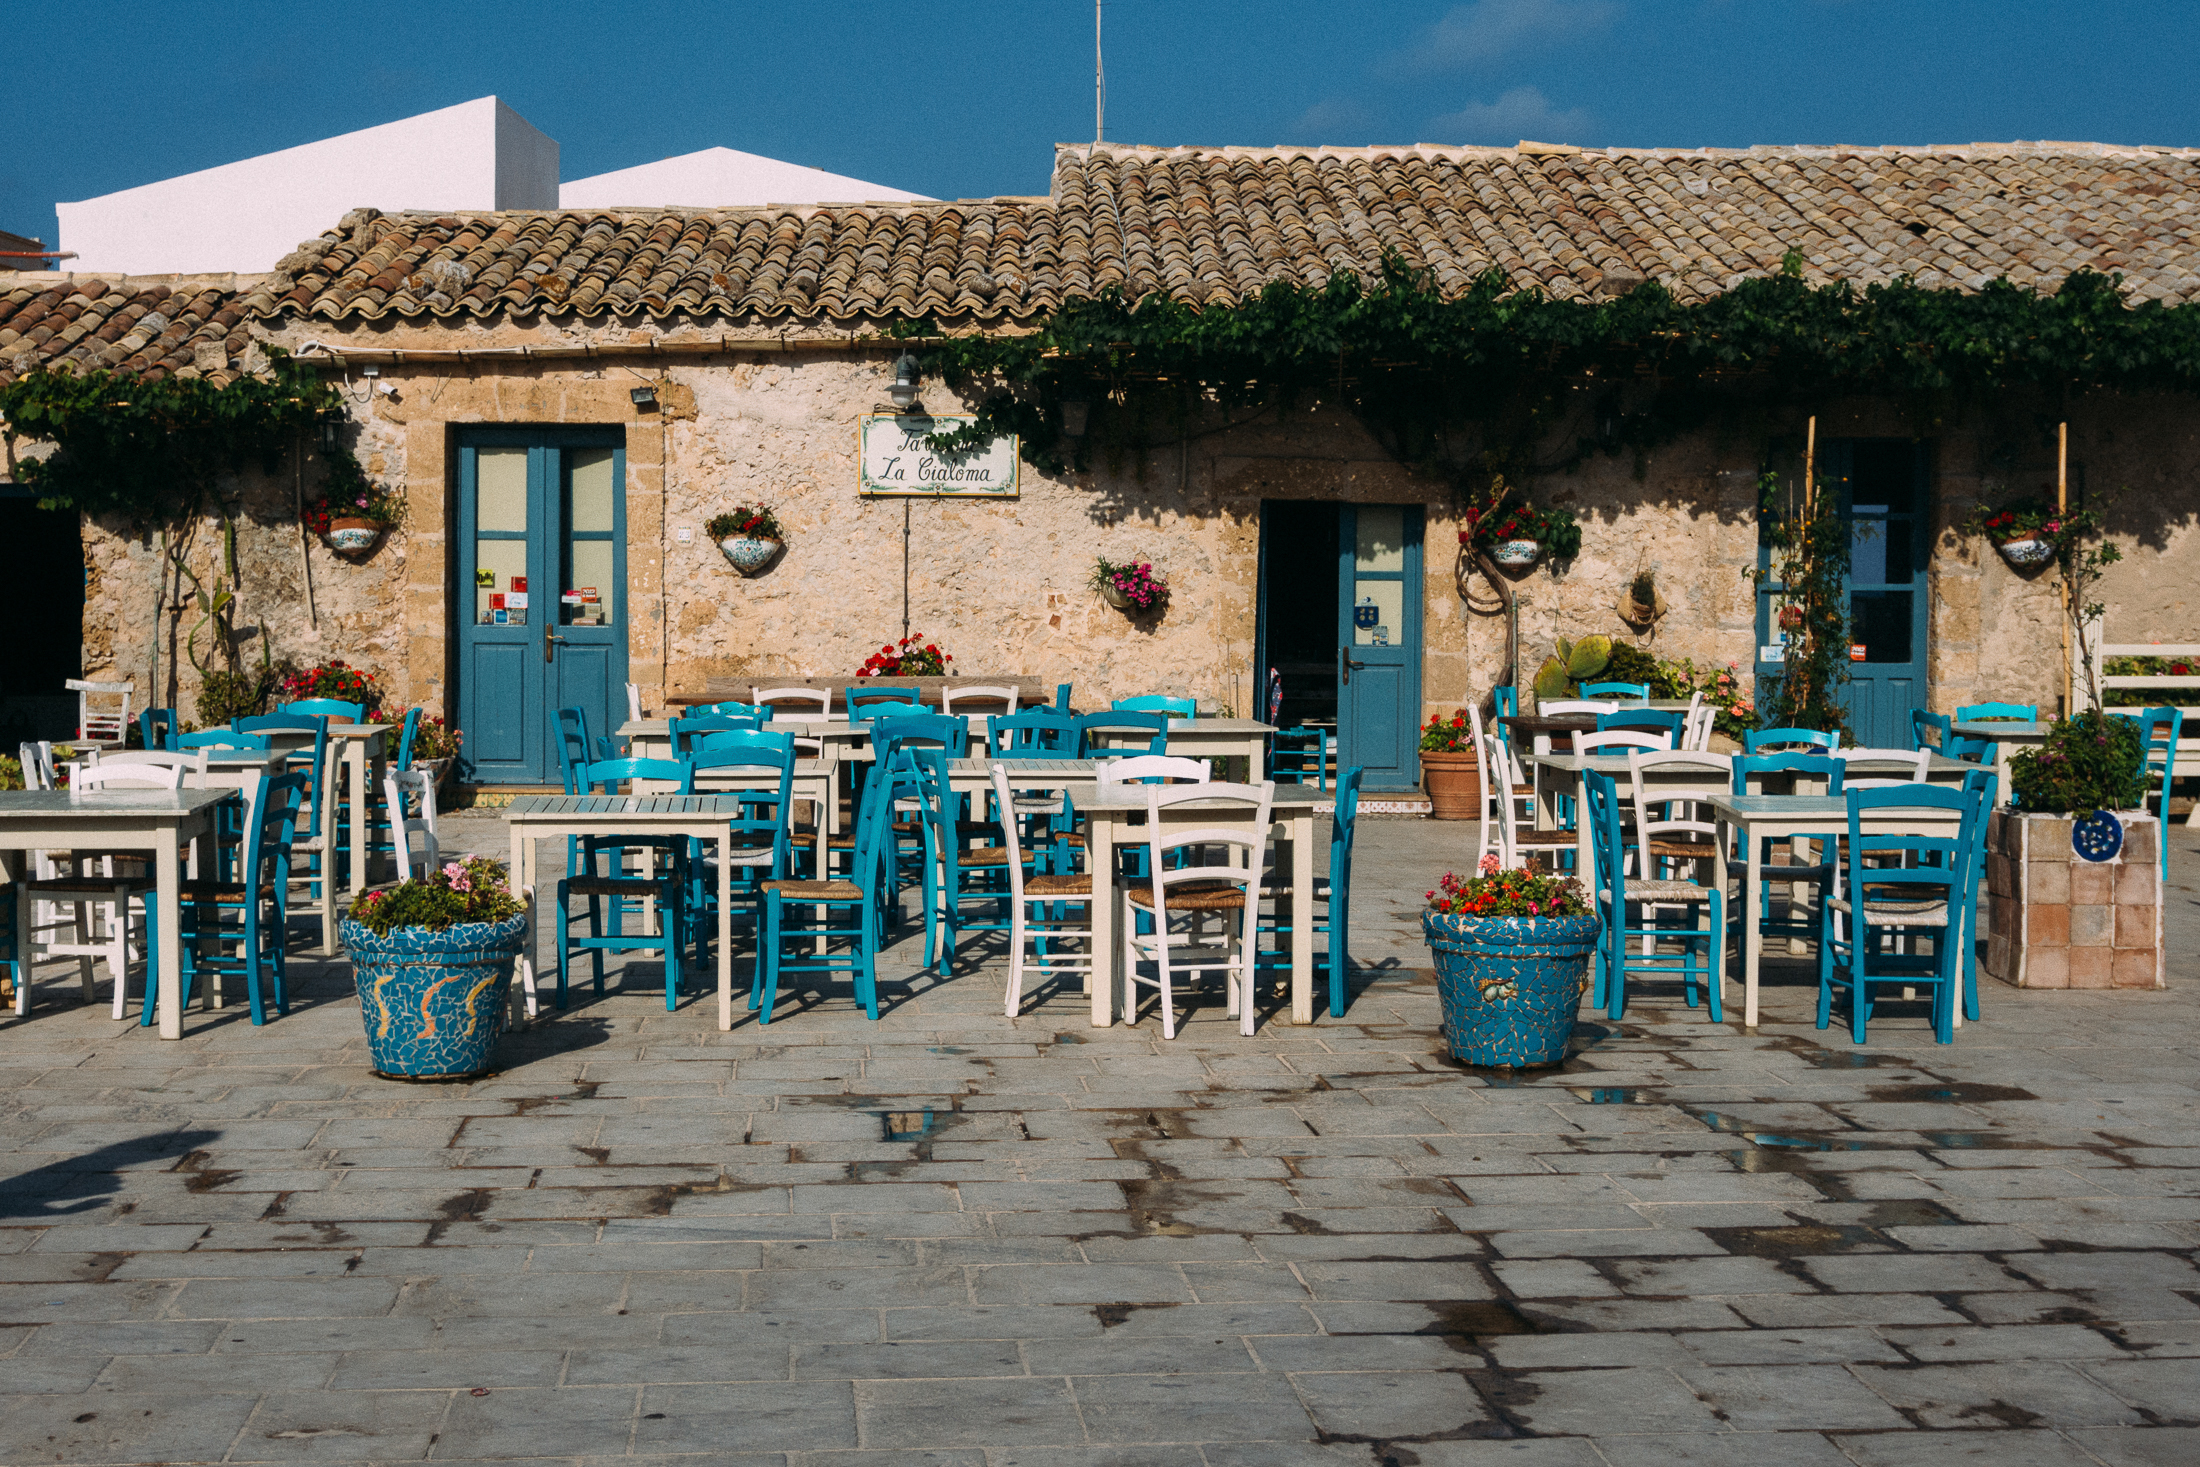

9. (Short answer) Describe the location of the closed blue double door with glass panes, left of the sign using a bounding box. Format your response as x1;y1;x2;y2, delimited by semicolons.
455;429;627;785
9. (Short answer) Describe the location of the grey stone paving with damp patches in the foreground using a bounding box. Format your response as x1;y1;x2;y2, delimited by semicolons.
0;820;2200;1467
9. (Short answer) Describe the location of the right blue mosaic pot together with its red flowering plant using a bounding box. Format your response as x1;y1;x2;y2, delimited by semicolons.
1421;853;1602;1067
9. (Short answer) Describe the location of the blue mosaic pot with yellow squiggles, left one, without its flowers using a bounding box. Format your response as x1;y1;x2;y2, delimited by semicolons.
339;915;528;1080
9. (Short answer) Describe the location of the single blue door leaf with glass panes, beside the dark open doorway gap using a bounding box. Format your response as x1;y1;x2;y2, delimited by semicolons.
1338;504;1421;792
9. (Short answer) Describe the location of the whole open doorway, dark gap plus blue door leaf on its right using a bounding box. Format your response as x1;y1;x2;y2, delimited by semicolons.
1254;499;1423;792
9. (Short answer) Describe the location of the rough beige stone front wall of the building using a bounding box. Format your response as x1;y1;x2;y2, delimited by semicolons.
42;312;2200;747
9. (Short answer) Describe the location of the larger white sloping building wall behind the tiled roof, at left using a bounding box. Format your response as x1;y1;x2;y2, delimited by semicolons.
57;97;557;275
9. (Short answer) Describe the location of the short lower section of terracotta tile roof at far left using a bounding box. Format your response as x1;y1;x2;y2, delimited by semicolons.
0;271;292;385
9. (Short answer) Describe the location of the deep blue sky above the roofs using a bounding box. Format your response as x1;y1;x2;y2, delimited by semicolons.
0;0;2200;242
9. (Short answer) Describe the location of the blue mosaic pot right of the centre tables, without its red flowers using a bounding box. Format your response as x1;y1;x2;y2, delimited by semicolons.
1421;911;1604;1065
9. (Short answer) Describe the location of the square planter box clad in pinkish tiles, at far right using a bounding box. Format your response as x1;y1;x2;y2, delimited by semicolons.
1987;809;2165;988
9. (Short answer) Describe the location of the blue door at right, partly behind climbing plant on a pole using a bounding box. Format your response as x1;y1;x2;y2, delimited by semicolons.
1758;438;1932;748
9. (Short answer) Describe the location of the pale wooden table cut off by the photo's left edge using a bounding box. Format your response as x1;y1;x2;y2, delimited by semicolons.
0;790;235;1038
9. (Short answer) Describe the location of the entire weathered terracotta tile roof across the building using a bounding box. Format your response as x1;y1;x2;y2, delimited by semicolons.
0;143;2200;374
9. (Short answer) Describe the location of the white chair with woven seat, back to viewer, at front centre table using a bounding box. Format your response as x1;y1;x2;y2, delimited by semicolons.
1120;781;1276;1038
